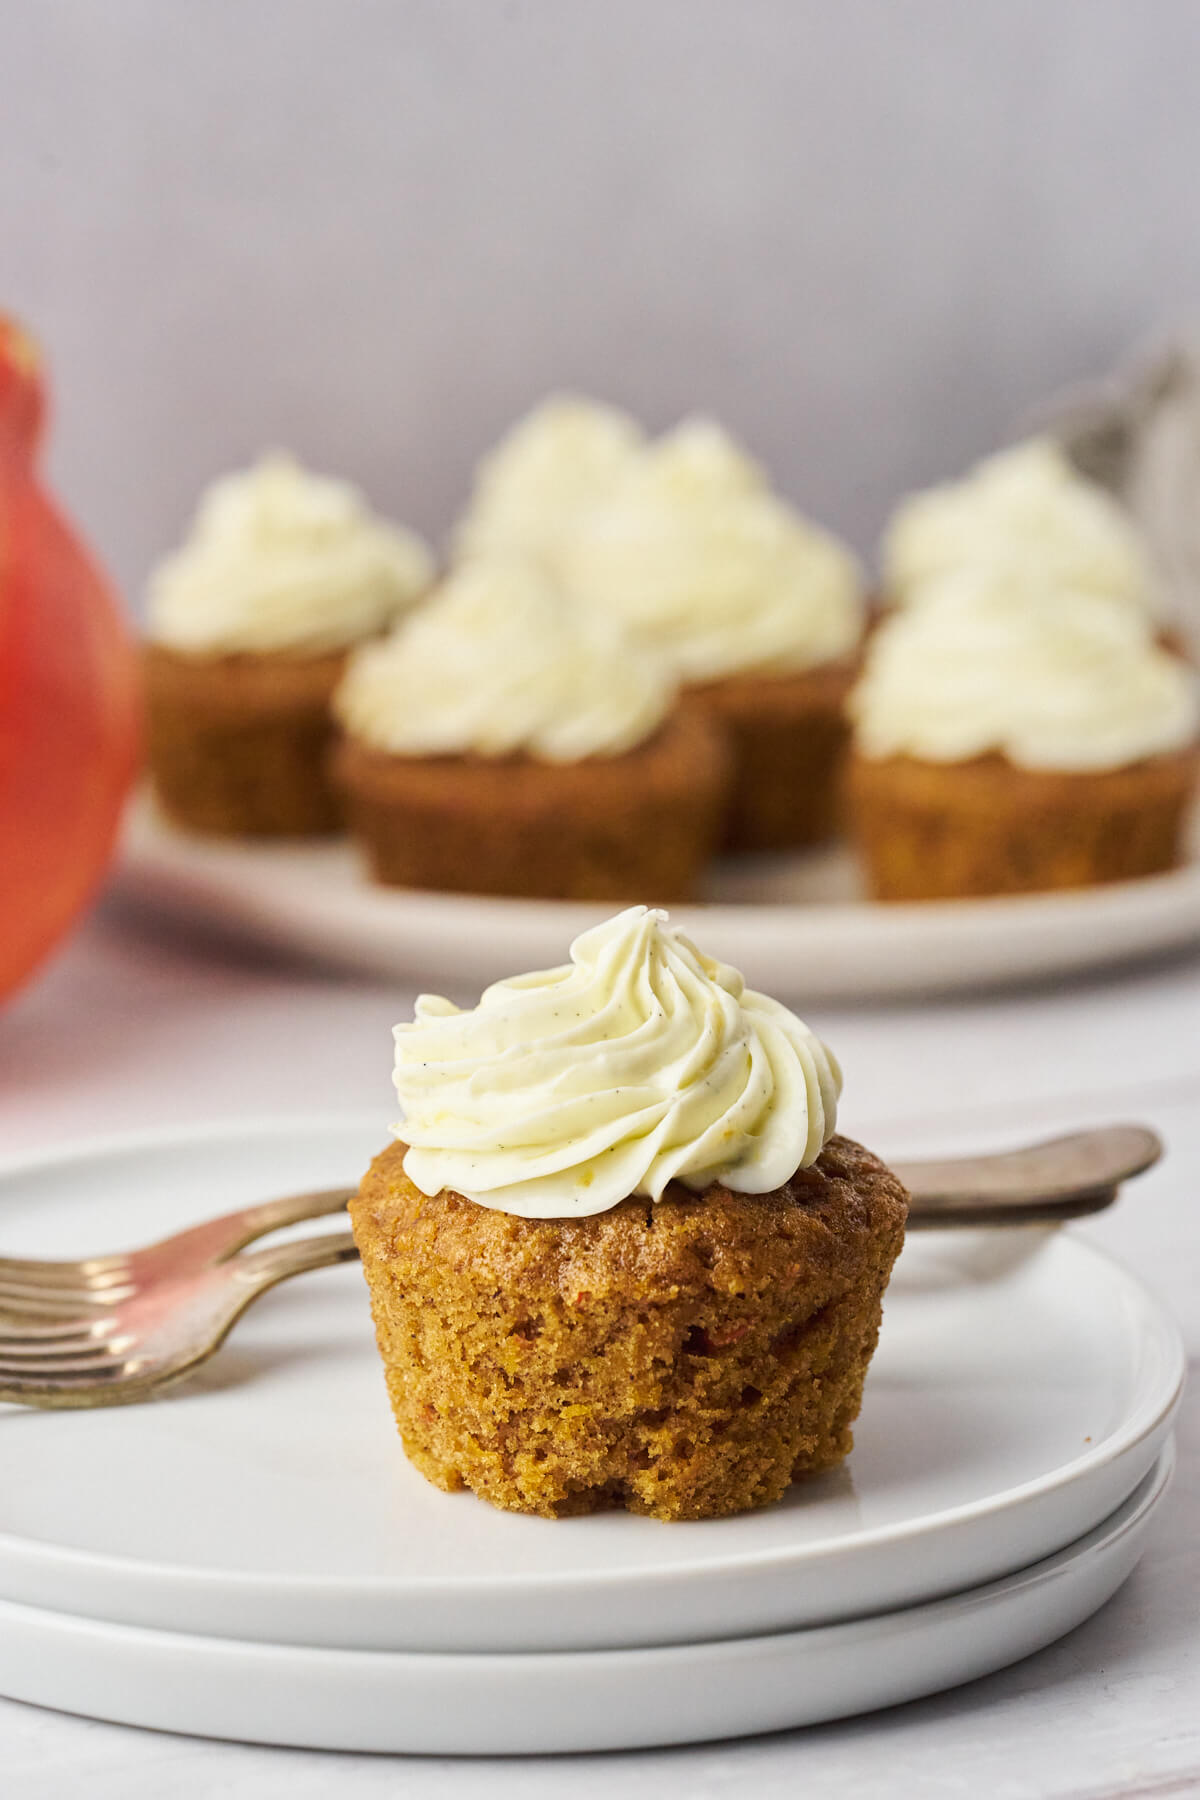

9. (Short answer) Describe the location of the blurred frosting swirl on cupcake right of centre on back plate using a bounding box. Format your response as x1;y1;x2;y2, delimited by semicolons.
563;421;864;682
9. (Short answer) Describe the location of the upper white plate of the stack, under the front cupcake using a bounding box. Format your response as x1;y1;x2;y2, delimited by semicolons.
0;1120;1184;1651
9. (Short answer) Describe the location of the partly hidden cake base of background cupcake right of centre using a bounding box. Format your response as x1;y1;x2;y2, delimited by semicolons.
687;659;858;851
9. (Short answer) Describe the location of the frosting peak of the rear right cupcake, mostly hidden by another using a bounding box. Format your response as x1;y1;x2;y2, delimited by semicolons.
883;437;1157;614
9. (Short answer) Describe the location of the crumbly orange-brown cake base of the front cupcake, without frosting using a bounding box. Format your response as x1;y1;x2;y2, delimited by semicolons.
351;1138;907;1519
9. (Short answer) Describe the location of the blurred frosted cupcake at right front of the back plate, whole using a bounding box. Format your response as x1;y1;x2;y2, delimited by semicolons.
849;571;1200;900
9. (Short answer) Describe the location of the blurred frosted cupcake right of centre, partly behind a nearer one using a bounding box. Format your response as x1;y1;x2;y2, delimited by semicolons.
563;421;864;850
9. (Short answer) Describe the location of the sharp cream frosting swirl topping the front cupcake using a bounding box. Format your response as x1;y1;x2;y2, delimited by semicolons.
394;905;842;1219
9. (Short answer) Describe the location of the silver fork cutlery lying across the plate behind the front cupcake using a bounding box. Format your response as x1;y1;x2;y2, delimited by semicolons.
0;1125;1162;1408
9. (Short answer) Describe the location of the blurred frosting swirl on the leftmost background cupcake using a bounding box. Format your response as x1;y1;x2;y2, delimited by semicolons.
149;455;434;655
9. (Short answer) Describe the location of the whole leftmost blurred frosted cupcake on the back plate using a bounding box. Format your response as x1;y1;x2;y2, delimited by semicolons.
144;455;432;837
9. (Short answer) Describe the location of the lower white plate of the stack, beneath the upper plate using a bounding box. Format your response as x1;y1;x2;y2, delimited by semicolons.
0;1445;1173;1756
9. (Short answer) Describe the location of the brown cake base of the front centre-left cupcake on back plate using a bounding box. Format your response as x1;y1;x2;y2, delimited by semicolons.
333;709;729;904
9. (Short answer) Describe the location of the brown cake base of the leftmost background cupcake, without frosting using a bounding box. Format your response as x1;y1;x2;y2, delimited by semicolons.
142;644;345;837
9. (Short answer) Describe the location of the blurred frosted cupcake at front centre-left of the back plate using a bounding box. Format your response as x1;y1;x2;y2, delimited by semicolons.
335;558;729;900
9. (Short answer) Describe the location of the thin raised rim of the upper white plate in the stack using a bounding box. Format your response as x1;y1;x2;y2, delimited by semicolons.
0;1112;1187;1605
